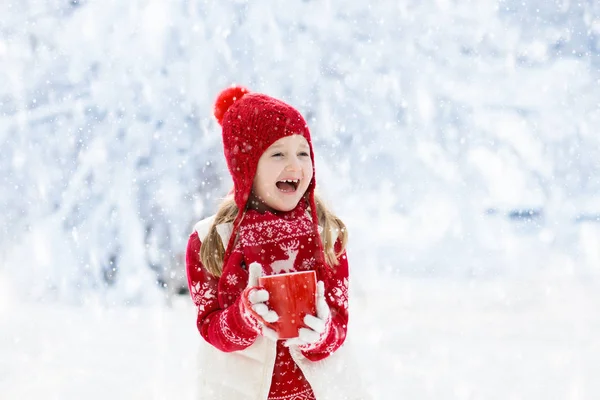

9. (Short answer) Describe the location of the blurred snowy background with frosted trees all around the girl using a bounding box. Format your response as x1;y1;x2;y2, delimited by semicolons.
0;0;600;399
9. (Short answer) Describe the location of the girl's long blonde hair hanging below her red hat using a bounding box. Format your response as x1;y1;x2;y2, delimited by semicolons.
200;194;348;276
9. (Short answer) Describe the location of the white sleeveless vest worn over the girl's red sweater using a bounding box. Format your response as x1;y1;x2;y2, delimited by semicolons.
194;216;371;400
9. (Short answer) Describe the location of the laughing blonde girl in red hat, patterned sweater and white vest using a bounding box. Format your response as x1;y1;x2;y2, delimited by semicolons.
186;86;363;400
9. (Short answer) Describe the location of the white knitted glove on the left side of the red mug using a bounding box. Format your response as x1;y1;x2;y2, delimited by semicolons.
242;262;279;340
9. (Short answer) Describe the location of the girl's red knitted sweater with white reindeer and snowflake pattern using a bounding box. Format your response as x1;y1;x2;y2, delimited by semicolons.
186;202;348;400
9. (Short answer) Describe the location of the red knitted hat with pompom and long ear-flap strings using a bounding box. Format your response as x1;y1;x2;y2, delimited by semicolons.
214;85;324;265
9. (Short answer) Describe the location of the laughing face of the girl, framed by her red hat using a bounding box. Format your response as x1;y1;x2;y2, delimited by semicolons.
252;135;313;211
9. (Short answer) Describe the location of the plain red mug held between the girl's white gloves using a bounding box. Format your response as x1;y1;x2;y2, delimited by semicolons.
258;271;317;339
